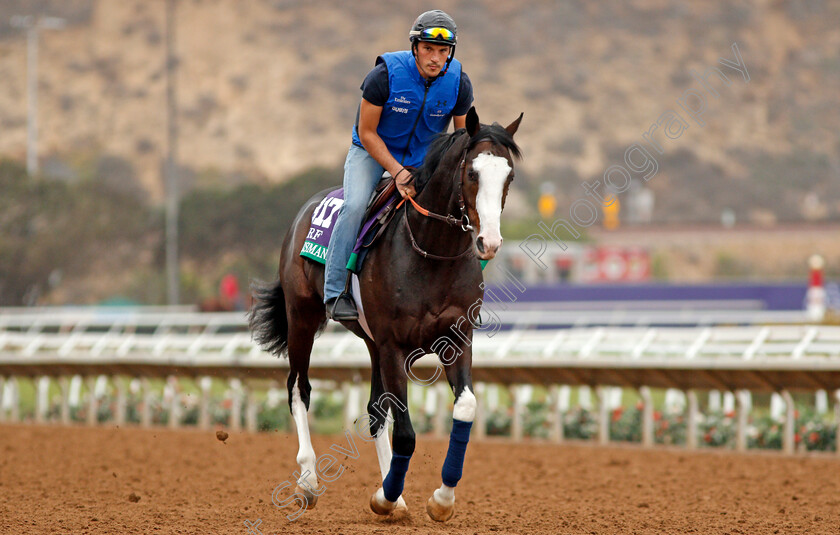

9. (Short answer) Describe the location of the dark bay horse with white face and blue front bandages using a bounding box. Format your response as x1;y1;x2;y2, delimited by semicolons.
249;108;522;522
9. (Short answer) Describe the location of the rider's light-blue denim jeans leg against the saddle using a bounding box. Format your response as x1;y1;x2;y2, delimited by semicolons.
324;145;384;302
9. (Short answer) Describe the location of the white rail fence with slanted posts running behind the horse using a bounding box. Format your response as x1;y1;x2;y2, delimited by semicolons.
0;309;840;453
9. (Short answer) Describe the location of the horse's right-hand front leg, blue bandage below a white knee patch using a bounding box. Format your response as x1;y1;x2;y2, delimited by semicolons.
426;352;476;522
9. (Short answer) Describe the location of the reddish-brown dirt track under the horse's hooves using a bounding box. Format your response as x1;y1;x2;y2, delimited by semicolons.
0;425;840;535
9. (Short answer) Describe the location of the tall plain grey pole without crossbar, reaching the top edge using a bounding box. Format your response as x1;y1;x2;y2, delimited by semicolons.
166;0;181;305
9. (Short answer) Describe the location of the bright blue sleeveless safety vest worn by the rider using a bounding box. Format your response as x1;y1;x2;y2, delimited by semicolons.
353;50;461;167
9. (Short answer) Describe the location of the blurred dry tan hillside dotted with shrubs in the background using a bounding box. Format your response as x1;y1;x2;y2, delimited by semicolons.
0;0;840;222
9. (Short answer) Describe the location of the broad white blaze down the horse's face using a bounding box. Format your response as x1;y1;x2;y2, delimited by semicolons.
472;152;510;252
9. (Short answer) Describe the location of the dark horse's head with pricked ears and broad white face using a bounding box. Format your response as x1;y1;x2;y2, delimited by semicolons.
460;108;522;260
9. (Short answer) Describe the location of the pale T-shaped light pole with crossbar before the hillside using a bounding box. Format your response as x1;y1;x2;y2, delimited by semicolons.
11;15;65;176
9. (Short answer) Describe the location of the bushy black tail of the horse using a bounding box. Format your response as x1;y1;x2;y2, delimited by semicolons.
248;279;289;357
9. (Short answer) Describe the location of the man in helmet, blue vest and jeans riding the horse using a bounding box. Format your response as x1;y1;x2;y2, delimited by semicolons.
324;10;473;320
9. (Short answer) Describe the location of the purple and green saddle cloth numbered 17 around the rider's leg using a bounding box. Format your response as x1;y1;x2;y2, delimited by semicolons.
300;173;399;273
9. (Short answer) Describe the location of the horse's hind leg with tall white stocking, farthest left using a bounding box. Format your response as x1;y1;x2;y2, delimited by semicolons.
286;311;327;509
